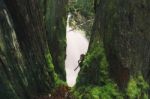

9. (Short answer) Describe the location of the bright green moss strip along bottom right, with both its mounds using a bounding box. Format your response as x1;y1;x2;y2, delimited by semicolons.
73;72;149;99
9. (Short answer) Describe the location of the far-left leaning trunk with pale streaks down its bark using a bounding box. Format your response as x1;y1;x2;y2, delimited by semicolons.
0;5;30;99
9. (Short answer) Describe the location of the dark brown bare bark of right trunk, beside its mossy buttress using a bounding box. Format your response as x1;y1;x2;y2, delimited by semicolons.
94;0;150;88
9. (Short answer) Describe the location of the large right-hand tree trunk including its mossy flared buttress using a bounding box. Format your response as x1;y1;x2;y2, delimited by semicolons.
77;0;150;92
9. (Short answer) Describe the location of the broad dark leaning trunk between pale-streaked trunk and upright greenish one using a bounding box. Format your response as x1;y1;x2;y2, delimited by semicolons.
5;0;54;92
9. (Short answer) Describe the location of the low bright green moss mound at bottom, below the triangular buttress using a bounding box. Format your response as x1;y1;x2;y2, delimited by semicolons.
74;82;123;99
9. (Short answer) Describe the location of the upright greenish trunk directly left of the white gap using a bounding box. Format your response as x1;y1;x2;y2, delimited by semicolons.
43;0;68;80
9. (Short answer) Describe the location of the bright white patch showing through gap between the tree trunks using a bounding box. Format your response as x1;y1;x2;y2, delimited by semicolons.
65;14;89;87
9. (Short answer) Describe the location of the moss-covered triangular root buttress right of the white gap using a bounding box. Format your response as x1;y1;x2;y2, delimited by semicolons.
76;16;110;88
